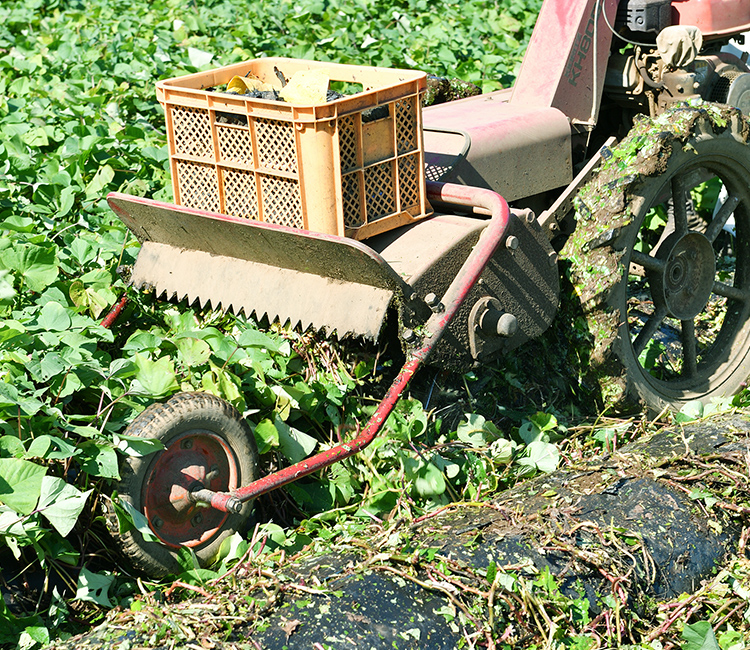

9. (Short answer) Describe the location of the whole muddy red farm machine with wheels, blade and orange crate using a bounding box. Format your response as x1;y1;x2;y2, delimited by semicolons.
109;0;750;575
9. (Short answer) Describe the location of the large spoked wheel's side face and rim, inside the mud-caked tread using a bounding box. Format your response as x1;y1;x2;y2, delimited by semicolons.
609;117;750;409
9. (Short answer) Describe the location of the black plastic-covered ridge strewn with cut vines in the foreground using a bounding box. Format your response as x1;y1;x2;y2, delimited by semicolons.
55;415;750;650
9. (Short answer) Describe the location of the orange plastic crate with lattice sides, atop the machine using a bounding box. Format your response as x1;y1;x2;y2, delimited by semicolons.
156;58;432;239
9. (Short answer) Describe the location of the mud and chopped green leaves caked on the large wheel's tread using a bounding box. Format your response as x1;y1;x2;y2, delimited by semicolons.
562;103;750;404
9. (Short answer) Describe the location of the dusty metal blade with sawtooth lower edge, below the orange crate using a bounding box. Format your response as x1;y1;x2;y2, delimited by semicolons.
108;193;409;339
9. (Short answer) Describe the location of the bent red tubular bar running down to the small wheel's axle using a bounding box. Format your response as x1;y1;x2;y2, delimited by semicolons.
193;183;510;512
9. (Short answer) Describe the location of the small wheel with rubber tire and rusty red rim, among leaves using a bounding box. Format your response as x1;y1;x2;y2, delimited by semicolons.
110;393;258;578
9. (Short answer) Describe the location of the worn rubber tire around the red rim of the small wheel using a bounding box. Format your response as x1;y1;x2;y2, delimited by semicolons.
108;393;259;579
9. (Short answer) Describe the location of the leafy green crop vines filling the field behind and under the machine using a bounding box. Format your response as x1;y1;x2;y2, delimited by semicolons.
0;0;541;648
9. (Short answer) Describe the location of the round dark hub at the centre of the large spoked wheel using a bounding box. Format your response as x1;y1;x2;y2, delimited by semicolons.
649;232;716;320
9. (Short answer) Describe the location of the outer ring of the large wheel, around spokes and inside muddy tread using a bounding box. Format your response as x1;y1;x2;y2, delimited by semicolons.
592;114;750;413
